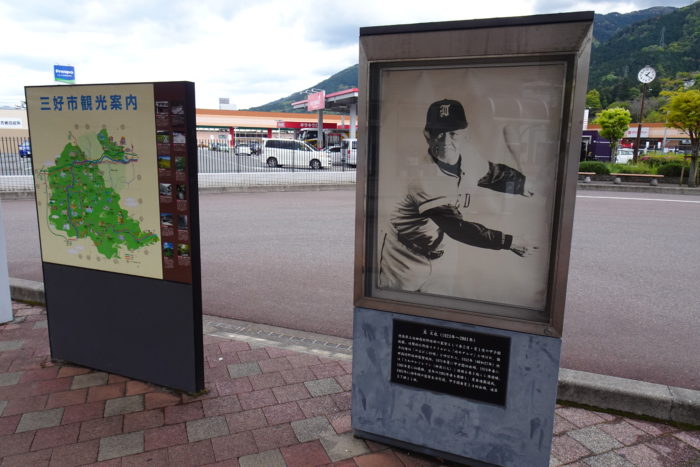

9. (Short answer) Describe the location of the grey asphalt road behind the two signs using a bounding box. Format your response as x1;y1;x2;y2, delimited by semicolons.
2;190;700;390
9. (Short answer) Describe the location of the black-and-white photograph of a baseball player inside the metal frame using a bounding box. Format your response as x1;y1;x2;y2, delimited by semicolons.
372;58;567;326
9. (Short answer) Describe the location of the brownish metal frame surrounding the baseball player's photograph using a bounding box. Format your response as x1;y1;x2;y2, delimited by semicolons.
354;12;593;337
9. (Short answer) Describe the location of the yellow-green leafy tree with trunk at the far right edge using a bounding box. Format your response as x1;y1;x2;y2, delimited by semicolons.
664;89;700;186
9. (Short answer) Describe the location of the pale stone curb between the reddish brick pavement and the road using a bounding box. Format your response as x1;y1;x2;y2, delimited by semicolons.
10;277;700;425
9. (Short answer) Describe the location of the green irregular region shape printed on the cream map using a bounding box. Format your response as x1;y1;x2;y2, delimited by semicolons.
47;130;158;259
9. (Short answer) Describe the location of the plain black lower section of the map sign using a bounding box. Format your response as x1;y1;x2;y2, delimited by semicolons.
44;263;204;393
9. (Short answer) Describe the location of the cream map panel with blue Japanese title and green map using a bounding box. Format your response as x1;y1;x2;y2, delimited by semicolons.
26;84;163;279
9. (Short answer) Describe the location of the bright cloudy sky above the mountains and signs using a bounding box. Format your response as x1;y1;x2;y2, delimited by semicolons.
0;0;693;109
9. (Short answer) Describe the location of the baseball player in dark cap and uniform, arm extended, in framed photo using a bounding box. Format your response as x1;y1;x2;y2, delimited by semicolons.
378;99;536;292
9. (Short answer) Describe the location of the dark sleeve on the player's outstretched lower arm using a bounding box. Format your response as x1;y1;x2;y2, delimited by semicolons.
426;206;513;250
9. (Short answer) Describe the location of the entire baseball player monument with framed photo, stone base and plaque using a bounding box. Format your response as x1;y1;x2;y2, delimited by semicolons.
352;12;594;467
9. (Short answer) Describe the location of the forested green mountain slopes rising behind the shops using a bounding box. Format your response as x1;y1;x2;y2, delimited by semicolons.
250;2;700;112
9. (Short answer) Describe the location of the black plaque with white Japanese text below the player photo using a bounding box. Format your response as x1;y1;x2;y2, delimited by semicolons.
391;320;510;405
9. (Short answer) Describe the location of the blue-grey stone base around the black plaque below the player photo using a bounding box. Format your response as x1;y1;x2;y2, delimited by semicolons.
352;308;561;467
